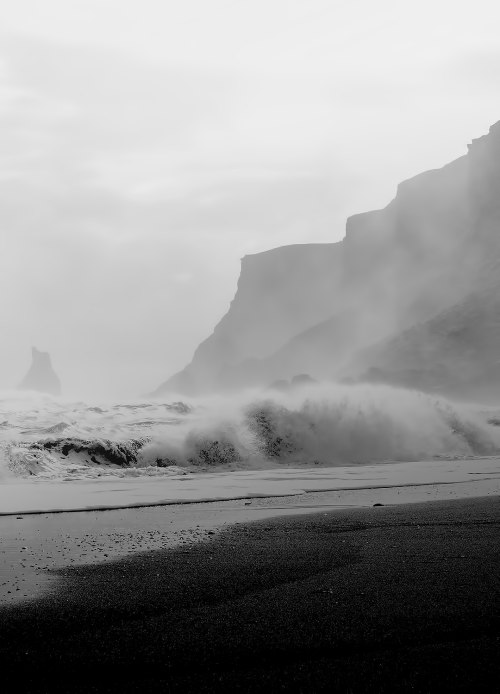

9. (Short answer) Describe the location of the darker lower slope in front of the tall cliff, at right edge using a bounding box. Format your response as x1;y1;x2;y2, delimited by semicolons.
349;280;500;404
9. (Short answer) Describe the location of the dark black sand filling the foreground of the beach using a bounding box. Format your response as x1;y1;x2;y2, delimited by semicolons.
0;497;500;693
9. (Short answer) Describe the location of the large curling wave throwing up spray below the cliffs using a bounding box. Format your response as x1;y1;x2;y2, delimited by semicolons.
137;385;500;469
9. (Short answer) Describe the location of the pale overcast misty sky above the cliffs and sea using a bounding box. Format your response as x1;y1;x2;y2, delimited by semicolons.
0;0;500;397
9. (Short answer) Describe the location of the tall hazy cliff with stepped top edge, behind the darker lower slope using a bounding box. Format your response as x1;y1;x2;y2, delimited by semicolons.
154;122;500;400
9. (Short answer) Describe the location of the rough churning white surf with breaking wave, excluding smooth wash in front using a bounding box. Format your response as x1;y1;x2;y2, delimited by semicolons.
0;384;500;482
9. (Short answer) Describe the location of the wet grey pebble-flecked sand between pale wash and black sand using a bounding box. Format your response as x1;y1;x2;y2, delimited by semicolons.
0;478;500;607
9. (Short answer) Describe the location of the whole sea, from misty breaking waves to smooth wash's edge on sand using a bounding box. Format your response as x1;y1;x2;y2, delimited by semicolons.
0;384;500;513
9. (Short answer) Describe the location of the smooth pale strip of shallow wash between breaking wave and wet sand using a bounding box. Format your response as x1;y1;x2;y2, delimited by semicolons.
0;456;500;517
